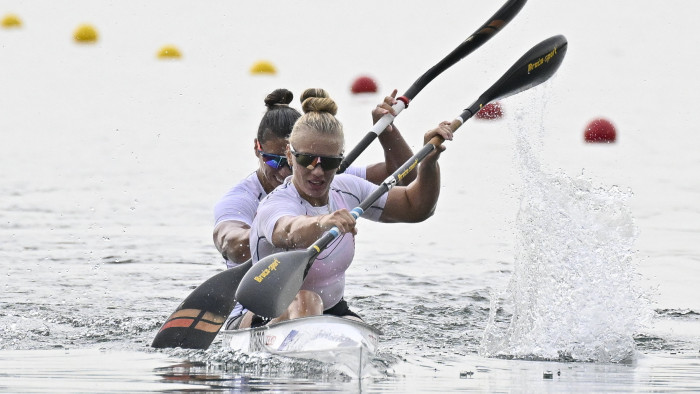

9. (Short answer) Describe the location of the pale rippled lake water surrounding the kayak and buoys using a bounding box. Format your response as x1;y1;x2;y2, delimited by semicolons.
0;0;700;392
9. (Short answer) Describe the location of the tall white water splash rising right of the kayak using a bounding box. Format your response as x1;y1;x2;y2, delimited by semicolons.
479;103;649;362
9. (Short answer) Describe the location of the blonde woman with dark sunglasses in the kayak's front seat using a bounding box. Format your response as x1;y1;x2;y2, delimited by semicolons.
237;89;452;328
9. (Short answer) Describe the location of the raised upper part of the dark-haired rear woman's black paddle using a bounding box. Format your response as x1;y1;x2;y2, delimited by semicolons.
338;0;527;174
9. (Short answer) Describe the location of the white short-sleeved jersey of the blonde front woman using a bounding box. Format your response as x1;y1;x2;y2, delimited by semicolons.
250;174;387;310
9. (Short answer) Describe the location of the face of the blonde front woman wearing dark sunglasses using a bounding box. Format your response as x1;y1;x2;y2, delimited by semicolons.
287;130;344;206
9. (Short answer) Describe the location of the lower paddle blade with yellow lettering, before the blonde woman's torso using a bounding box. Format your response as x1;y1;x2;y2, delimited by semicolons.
236;249;316;318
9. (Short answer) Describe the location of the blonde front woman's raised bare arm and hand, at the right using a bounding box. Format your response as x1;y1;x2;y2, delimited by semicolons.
380;122;452;223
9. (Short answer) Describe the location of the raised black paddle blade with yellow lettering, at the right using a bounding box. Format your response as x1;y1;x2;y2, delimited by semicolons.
479;35;568;105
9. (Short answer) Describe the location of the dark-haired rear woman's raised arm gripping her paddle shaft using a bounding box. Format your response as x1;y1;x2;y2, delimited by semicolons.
360;89;416;185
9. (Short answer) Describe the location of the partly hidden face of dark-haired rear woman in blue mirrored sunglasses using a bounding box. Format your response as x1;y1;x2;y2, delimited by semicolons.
255;138;292;193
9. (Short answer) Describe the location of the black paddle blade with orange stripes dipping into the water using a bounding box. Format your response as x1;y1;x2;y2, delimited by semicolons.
151;260;252;349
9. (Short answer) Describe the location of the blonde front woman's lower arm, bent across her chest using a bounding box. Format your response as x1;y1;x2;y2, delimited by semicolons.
272;209;356;249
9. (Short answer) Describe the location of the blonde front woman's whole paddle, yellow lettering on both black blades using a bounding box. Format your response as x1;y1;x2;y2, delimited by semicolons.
236;35;567;317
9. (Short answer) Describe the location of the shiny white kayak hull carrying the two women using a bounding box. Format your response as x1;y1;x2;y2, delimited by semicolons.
219;315;382;377
